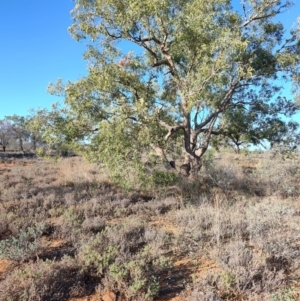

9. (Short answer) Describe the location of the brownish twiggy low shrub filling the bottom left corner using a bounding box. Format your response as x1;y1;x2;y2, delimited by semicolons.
0;257;91;301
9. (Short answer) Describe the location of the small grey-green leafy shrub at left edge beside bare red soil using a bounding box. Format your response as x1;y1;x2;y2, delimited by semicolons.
0;223;45;262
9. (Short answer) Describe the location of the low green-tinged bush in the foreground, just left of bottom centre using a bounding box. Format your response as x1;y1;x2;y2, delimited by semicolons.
78;225;170;300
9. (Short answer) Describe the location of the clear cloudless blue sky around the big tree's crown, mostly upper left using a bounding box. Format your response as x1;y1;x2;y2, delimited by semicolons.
0;0;300;119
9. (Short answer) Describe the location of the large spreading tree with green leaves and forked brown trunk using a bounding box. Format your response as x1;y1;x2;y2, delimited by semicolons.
35;0;300;184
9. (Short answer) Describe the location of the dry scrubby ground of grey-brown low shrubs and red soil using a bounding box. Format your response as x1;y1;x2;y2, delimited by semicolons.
0;153;300;301
